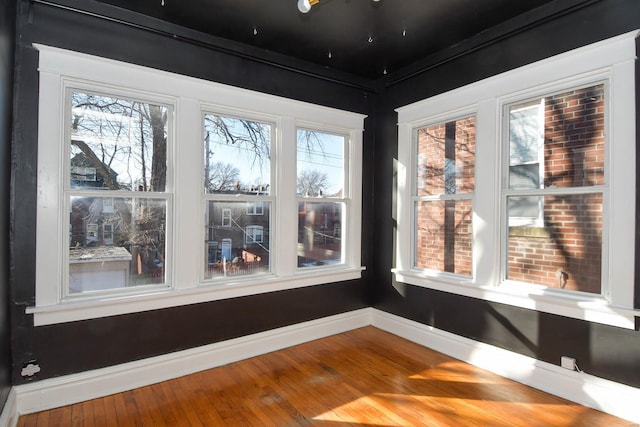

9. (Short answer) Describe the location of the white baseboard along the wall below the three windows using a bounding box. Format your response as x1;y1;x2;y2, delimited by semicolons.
14;308;371;415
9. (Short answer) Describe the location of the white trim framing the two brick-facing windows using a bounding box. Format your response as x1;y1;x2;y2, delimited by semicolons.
393;31;640;329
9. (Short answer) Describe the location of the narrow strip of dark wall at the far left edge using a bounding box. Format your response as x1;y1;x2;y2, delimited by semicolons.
0;0;16;410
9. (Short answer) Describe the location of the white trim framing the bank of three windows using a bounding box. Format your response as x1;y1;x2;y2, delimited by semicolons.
26;44;366;326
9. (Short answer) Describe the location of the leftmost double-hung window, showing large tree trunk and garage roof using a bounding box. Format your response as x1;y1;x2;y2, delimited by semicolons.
63;89;171;296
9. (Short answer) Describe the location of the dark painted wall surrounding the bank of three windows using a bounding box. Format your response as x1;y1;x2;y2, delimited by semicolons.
10;1;374;384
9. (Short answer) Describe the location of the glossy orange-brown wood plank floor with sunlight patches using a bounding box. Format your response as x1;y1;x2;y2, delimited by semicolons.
18;327;633;427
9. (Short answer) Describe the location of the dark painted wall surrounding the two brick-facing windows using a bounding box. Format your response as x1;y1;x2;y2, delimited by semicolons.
372;0;640;387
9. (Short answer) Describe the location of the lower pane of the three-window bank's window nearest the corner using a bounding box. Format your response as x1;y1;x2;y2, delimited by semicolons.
298;202;343;267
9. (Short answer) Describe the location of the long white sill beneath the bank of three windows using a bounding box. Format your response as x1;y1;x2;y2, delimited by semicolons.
26;266;365;326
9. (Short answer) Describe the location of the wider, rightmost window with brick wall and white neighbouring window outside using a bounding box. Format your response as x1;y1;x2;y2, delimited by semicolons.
505;83;606;295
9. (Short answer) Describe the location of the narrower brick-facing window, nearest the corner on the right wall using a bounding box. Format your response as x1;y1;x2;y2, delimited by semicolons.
413;116;476;276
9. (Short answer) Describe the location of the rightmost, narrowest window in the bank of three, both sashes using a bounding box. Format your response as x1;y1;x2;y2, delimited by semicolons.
296;128;348;268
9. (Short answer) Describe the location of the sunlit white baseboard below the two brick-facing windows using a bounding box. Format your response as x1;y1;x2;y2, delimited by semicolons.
371;309;640;423
